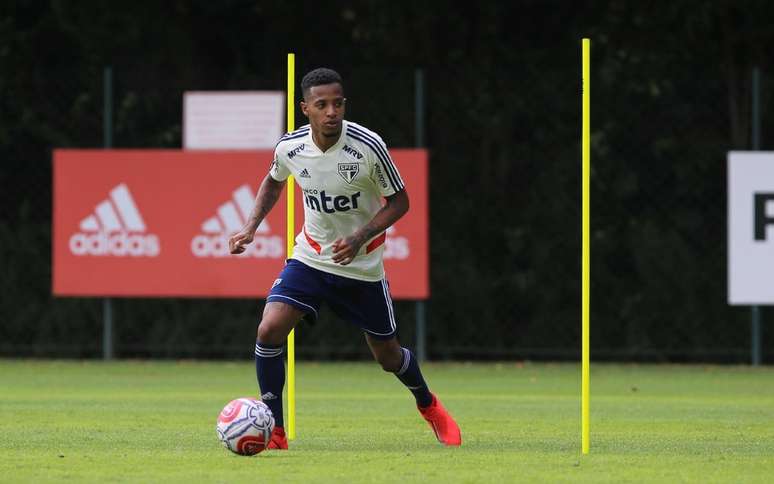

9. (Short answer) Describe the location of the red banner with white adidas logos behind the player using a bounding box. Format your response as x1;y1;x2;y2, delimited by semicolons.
52;150;429;299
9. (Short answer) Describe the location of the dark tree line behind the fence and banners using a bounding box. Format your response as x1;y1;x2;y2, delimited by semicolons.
0;0;774;361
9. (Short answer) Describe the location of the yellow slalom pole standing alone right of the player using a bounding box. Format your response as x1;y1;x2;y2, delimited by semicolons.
581;39;591;454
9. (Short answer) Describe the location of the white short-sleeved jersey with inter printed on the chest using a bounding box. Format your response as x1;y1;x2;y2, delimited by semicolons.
269;120;403;281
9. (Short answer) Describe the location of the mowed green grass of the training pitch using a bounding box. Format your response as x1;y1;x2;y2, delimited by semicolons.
0;360;774;483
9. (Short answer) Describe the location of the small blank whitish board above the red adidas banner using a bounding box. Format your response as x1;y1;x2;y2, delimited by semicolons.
183;91;285;150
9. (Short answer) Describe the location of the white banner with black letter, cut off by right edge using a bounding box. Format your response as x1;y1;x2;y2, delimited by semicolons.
728;151;774;305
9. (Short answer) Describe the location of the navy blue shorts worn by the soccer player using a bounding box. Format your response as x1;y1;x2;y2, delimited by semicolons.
266;259;396;339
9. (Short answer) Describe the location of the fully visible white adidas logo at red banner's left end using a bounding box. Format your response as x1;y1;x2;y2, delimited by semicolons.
69;183;161;257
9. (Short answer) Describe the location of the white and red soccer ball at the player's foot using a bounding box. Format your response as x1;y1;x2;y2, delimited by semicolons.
216;398;274;455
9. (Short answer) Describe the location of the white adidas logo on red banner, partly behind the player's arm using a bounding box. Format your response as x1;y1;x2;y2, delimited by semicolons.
191;185;285;259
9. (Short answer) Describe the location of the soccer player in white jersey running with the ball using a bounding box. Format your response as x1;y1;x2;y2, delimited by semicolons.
229;69;462;449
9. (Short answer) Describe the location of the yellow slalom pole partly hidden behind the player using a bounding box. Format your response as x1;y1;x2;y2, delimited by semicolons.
286;54;296;440
